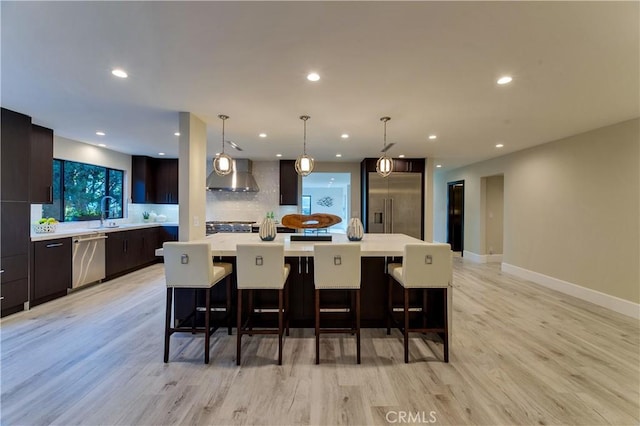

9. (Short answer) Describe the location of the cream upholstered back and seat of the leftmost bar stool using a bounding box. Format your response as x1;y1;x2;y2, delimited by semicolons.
162;242;228;288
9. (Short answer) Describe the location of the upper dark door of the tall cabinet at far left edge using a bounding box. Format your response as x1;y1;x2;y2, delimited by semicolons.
0;108;31;201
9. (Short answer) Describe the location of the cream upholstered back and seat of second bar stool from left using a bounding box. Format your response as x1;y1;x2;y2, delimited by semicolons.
236;243;289;289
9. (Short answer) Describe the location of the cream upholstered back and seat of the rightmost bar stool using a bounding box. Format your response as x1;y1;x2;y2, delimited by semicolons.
390;243;453;288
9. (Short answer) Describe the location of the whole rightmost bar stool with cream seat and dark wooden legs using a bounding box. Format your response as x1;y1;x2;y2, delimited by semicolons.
387;244;453;363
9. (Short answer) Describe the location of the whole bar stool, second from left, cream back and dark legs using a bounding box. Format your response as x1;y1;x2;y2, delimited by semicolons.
236;243;291;365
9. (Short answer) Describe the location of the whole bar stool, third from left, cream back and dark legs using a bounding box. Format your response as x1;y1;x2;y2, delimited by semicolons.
313;244;361;364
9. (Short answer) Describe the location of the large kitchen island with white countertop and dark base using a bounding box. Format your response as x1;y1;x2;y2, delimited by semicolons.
156;233;452;338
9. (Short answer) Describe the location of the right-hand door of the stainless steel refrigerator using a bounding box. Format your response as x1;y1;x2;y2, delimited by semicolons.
387;172;422;239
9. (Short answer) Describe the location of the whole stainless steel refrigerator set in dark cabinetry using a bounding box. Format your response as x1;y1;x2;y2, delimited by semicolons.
367;172;423;239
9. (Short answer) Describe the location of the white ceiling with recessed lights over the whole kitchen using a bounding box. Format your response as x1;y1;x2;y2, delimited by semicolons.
1;1;640;169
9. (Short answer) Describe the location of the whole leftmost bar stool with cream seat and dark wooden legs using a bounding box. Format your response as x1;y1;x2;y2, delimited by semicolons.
162;242;233;364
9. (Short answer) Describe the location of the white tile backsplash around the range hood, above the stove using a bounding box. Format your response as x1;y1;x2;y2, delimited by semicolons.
206;161;298;222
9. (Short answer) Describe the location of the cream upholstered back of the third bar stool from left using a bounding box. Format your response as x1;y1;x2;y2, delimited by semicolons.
313;243;361;289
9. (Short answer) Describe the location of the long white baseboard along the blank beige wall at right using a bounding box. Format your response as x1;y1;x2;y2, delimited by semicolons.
502;262;640;319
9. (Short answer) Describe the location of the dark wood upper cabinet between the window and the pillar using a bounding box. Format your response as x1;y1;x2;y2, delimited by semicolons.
131;155;178;204
